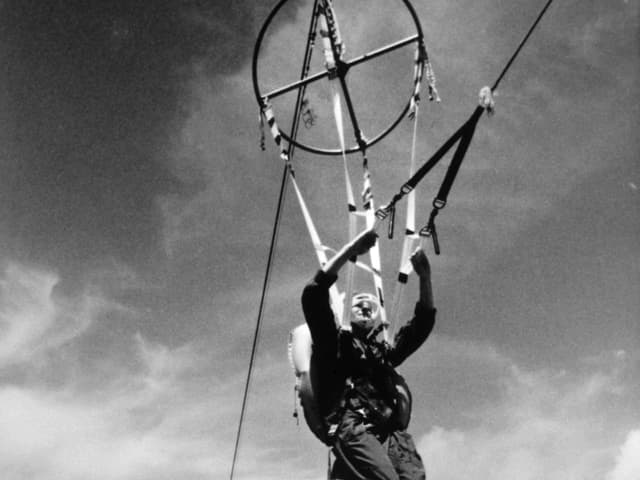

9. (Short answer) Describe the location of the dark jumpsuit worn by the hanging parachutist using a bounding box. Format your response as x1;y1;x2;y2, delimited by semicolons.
302;270;436;480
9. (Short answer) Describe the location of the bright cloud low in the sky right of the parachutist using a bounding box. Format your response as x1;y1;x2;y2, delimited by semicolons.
419;342;638;480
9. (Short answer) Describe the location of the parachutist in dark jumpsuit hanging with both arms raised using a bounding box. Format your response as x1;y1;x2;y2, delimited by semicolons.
301;229;436;480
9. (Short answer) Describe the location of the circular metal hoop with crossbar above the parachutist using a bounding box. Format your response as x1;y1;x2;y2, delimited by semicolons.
252;0;426;155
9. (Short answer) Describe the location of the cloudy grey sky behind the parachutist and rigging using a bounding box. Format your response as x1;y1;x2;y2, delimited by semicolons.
0;0;640;480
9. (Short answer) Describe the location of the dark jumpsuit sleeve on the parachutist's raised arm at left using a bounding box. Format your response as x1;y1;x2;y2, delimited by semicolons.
302;270;338;357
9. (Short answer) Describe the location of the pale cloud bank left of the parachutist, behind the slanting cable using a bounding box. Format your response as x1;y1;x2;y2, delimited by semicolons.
0;258;310;480
